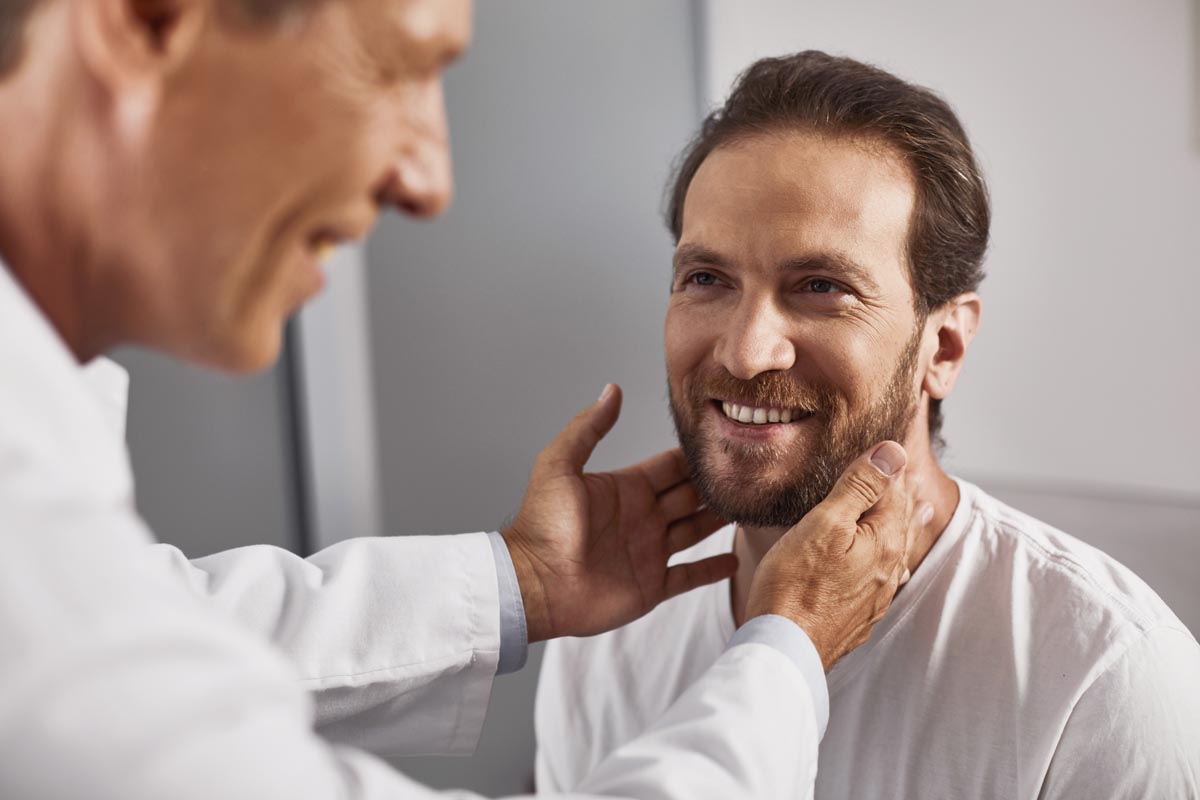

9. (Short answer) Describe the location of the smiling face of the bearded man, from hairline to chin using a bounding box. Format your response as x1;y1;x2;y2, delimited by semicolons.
666;132;922;527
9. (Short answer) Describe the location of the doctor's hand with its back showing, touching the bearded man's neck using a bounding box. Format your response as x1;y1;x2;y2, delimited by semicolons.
745;441;932;672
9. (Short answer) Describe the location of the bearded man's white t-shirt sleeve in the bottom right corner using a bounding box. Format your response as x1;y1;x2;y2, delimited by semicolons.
1039;626;1200;800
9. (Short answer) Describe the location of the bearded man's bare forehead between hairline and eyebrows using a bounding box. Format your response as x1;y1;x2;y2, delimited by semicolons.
679;131;916;288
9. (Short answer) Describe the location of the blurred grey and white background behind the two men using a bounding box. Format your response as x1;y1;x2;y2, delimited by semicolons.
119;0;1200;794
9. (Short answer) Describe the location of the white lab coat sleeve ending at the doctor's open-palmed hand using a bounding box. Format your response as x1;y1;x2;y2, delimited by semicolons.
151;534;500;756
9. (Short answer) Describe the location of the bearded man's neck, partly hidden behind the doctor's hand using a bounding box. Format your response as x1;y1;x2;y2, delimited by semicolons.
730;443;959;627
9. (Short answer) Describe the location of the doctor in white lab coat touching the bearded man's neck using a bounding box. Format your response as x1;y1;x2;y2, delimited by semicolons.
0;0;923;800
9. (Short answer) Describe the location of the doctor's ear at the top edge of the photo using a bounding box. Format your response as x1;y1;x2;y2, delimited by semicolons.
71;0;212;108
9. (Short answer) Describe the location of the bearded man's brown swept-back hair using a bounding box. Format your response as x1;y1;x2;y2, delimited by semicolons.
666;50;991;445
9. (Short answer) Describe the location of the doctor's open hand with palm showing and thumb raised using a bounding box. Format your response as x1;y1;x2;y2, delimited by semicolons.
503;384;737;642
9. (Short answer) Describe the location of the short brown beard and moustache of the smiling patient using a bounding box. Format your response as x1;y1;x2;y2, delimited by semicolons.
668;325;922;528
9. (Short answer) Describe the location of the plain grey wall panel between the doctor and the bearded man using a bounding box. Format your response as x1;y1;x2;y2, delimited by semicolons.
367;0;697;793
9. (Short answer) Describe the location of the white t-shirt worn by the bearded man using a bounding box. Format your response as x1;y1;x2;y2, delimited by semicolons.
536;481;1200;800
